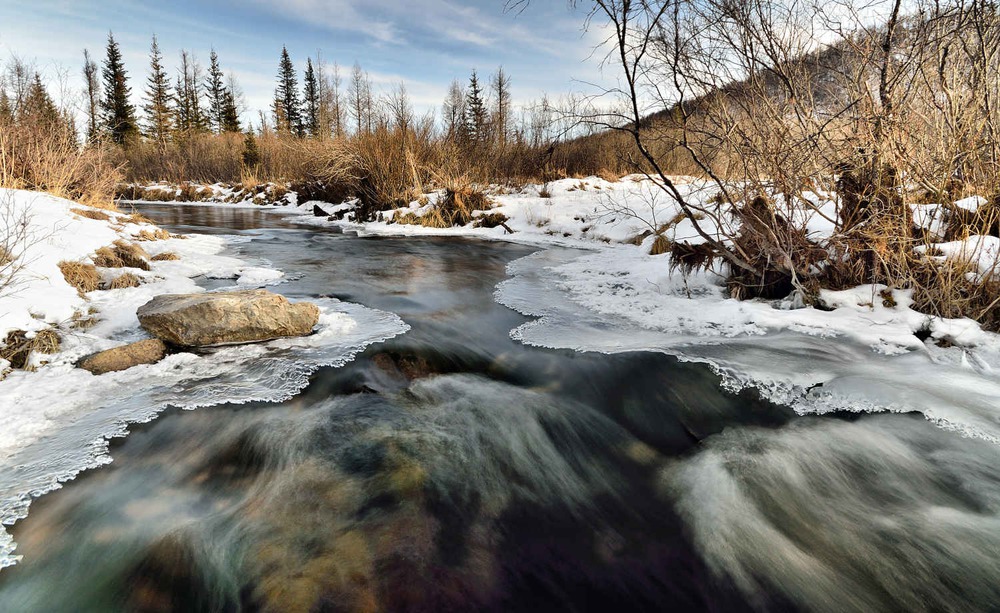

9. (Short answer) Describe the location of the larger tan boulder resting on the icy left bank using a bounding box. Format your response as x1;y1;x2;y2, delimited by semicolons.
136;290;319;347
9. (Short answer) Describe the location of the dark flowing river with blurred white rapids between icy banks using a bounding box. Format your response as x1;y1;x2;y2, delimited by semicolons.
0;206;1000;611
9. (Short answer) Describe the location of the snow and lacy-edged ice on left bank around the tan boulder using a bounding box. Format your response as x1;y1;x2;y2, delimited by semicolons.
0;190;407;568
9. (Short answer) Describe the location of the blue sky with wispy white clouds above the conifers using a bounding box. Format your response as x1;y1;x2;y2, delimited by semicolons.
0;0;613;126
